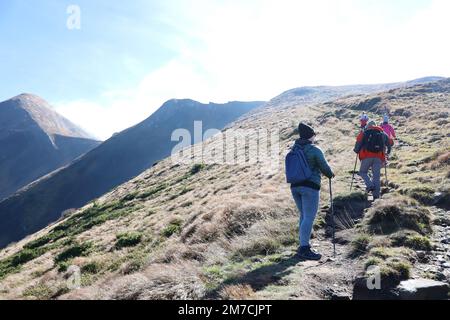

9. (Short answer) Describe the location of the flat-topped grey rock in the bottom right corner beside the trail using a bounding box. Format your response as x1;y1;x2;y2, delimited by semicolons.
396;279;449;300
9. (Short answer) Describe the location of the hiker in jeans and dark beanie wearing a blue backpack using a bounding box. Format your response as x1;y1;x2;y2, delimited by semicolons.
286;123;334;260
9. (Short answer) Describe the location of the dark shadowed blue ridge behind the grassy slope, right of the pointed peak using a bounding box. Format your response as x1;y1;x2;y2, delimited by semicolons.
0;100;262;247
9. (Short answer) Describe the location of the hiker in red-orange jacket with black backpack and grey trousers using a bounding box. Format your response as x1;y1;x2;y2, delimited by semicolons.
354;121;392;200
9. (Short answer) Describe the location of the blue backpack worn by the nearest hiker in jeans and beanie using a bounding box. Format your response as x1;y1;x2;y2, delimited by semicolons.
286;145;312;184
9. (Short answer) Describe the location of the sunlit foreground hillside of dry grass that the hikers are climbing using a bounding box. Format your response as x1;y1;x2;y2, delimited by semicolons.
0;79;450;299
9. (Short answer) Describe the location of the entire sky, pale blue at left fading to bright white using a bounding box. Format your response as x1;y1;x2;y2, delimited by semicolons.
0;0;450;139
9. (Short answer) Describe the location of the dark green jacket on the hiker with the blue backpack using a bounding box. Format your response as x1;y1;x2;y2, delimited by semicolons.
293;139;334;190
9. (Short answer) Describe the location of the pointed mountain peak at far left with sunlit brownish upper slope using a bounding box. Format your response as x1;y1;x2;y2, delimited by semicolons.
0;94;99;200
